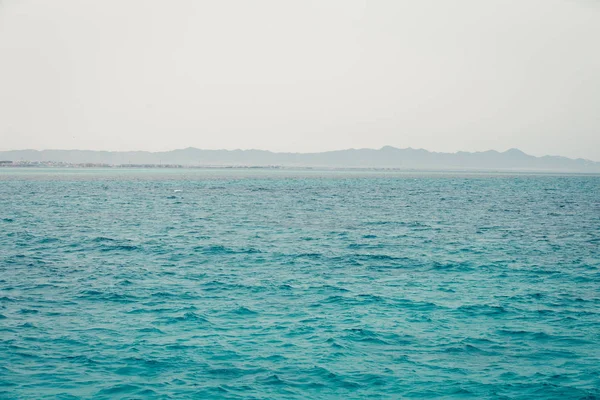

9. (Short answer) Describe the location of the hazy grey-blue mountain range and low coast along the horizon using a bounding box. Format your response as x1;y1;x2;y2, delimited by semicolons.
0;146;600;172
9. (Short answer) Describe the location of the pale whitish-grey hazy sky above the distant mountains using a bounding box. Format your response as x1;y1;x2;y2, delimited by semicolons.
0;0;600;161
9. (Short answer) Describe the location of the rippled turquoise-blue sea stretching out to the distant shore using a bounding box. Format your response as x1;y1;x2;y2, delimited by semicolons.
0;168;600;399
